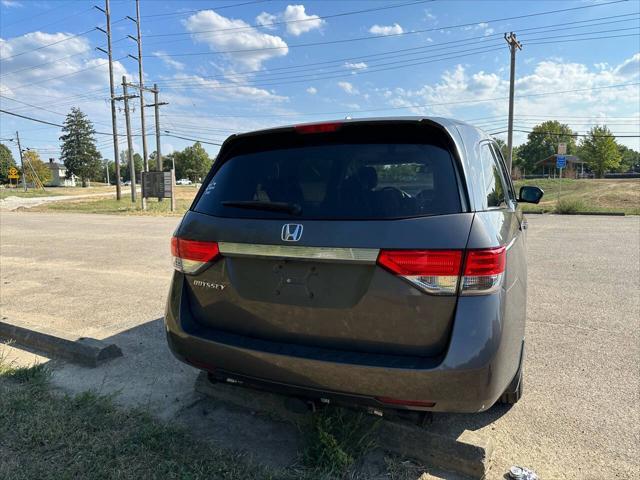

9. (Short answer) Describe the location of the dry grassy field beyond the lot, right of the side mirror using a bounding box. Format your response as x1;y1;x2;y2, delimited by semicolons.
515;178;640;215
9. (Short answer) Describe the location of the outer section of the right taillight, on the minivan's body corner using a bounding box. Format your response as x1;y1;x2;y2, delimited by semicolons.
460;247;507;295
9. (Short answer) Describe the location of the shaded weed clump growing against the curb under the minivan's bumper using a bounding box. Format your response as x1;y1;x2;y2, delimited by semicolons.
303;408;378;476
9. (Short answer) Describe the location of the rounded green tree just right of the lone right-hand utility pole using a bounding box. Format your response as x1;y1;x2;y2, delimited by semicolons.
518;120;576;172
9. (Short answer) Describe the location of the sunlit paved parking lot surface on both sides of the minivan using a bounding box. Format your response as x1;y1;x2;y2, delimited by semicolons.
0;213;640;479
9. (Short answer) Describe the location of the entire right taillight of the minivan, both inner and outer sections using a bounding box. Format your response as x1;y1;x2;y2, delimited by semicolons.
378;247;506;295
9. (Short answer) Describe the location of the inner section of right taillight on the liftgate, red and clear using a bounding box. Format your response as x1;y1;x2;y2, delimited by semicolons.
378;250;462;295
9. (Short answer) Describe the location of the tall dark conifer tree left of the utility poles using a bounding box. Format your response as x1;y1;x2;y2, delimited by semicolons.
60;107;102;187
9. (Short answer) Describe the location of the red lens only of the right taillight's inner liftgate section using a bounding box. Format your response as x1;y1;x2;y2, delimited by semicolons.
378;250;462;276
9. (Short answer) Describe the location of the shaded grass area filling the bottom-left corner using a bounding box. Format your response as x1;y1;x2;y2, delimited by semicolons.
0;365;284;480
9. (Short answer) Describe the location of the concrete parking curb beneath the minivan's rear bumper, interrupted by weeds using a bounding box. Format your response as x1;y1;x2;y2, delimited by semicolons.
195;372;494;479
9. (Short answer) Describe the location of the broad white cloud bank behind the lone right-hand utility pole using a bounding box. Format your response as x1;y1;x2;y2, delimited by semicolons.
382;54;640;146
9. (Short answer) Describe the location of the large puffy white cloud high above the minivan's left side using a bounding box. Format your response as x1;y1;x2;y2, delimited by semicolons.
183;10;289;70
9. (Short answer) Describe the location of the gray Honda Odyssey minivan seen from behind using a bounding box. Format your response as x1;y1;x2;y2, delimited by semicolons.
165;117;543;412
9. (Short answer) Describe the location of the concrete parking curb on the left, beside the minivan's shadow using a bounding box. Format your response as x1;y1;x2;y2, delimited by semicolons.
0;321;122;367
